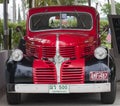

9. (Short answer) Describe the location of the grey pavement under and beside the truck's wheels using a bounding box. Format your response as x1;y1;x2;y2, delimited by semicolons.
0;82;120;106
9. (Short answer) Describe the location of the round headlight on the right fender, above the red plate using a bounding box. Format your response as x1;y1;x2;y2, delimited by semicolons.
94;47;107;60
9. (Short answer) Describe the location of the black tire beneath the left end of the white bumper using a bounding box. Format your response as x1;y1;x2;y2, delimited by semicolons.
6;93;21;105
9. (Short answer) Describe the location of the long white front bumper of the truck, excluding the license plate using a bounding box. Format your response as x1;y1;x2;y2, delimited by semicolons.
7;83;111;94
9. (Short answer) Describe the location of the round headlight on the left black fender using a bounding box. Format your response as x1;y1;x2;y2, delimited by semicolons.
12;49;23;61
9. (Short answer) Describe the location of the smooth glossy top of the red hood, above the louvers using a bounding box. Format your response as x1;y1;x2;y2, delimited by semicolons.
30;33;94;46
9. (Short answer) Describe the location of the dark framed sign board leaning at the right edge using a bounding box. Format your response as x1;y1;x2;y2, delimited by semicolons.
108;15;120;57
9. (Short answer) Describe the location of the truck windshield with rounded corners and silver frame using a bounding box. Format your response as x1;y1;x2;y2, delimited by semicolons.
30;12;92;31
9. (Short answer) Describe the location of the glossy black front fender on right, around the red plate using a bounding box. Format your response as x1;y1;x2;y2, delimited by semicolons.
85;55;116;82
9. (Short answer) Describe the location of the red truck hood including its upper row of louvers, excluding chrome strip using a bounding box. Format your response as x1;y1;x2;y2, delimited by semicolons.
27;32;97;58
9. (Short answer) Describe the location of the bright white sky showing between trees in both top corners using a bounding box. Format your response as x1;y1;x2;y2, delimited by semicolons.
0;0;120;20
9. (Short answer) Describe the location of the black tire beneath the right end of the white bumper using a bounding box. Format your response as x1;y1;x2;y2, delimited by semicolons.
101;80;116;104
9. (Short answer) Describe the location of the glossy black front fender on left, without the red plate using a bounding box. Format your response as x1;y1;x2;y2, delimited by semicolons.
6;57;33;83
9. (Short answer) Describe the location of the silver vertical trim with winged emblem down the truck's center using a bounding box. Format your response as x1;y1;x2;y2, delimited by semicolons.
49;34;69;83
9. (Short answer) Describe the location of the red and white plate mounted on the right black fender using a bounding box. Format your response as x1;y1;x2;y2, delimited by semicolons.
90;71;108;81
